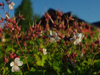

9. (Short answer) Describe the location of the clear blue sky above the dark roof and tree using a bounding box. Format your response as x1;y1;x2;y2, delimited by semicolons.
0;0;100;23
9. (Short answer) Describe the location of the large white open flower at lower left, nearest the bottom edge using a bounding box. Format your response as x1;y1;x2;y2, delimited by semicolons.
10;58;23;72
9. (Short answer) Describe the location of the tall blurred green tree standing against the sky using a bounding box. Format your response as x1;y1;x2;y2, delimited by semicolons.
15;0;34;31
